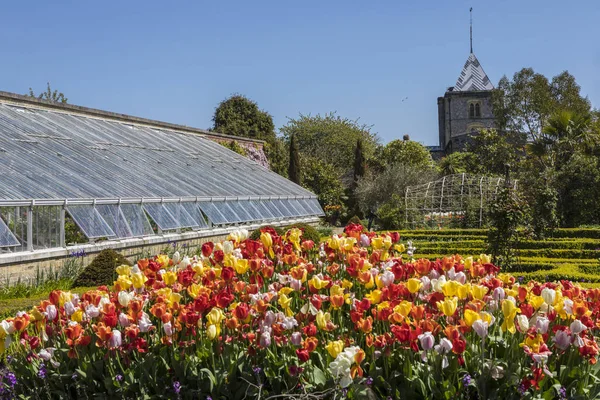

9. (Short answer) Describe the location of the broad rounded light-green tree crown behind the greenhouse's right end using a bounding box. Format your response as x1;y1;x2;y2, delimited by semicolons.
280;113;378;177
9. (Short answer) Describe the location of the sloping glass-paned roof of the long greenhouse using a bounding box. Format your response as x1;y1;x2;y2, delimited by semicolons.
0;92;315;203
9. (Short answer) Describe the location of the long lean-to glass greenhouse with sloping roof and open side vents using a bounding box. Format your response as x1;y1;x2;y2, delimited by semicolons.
0;92;323;255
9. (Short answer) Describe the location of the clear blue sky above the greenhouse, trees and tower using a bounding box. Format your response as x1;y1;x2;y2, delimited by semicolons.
0;0;600;144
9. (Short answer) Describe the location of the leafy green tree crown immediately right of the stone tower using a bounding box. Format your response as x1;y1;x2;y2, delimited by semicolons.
492;68;590;140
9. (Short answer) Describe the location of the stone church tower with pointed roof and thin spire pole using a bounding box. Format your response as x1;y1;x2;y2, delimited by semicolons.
438;9;495;155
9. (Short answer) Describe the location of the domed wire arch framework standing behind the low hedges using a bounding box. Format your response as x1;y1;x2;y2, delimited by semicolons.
404;173;517;229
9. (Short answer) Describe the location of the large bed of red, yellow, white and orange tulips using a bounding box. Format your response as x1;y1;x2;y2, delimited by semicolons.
0;225;600;399
